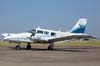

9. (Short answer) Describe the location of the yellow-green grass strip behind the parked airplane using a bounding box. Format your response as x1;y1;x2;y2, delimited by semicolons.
0;40;100;47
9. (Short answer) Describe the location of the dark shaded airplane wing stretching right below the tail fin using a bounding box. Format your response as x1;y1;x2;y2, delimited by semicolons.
49;35;96;42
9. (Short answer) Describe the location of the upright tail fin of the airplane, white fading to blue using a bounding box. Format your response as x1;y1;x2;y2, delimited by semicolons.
69;18;87;33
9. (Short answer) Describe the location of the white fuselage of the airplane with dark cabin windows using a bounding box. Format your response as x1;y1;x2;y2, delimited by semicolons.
1;28;85;42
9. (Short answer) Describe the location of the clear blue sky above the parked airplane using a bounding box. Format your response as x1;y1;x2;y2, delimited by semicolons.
0;0;100;36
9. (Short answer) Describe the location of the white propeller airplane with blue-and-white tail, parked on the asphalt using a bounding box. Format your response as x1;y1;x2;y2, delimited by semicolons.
1;18;95;50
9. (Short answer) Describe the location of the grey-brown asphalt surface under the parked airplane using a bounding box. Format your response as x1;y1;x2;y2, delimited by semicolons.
0;46;100;66
